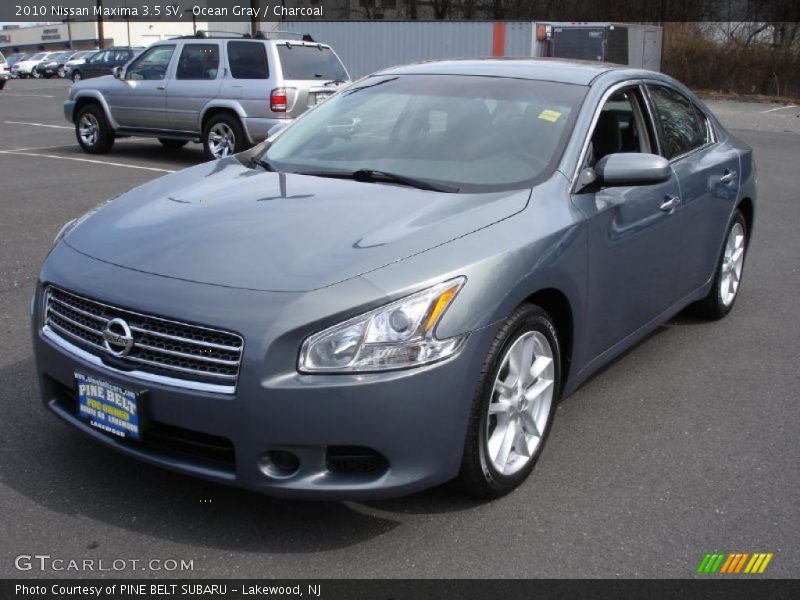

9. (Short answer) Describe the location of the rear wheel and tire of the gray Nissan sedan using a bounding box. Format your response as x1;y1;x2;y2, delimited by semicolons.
692;209;748;321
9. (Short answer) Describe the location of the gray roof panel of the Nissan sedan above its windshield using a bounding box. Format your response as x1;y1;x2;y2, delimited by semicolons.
372;58;627;85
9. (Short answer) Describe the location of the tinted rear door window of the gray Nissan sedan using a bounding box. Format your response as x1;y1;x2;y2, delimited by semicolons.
648;85;708;159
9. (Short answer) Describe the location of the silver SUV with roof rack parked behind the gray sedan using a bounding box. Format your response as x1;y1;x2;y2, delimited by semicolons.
64;35;350;159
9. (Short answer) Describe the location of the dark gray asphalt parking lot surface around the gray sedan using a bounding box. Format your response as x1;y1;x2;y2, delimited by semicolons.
0;80;800;578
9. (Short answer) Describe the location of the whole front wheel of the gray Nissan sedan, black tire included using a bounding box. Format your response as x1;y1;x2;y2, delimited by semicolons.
456;304;561;498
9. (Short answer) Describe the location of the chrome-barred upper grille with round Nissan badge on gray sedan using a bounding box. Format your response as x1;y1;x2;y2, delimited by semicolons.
44;286;244;389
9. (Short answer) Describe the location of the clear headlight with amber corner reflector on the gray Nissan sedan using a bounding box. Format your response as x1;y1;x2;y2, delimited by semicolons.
298;277;467;373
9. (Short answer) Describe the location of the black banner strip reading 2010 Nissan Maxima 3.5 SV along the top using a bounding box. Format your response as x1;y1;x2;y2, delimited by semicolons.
0;0;800;23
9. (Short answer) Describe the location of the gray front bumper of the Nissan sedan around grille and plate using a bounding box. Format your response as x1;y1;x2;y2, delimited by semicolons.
33;244;489;499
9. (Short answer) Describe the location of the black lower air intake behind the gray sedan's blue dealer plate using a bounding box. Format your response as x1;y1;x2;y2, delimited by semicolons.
51;376;236;472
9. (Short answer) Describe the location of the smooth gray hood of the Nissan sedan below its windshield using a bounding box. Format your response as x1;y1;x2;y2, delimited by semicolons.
65;158;530;292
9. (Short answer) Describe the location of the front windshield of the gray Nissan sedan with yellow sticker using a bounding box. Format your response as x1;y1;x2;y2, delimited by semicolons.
261;75;587;193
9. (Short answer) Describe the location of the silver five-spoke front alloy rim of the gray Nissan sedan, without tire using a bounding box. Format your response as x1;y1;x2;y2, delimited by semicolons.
486;331;555;476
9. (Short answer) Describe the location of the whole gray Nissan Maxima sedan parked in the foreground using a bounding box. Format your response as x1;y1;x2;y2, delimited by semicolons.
32;59;756;498
